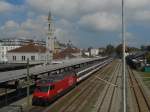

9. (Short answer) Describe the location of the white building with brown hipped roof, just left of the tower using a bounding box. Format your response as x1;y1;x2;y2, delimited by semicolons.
7;43;46;63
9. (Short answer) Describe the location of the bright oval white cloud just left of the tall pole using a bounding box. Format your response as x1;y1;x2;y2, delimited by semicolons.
79;13;121;31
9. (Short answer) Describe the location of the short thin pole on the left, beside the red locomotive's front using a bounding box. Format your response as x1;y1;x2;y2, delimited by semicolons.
27;58;30;107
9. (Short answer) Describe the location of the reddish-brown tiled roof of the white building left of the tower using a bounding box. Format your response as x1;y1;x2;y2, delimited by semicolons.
8;43;46;53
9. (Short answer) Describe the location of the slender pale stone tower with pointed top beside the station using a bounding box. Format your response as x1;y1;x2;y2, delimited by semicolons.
46;12;55;63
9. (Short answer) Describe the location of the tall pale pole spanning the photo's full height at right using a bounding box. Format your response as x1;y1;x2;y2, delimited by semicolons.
122;0;127;112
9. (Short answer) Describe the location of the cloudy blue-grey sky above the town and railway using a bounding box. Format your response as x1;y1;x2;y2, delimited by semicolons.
0;0;150;48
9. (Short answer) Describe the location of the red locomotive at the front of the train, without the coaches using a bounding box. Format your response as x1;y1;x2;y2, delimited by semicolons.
32;72;77;105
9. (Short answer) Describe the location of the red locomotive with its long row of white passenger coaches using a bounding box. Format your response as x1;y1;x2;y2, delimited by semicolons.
32;58;112;106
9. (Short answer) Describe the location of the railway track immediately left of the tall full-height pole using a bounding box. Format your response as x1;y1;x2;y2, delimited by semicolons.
93;63;121;112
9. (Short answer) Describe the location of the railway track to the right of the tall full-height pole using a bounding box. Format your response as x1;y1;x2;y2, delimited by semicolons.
127;67;150;112
